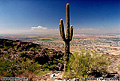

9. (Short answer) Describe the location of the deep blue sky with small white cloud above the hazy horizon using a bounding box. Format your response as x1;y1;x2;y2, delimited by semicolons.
0;0;120;34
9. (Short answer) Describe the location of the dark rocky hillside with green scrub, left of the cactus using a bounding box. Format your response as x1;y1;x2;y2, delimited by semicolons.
0;39;63;78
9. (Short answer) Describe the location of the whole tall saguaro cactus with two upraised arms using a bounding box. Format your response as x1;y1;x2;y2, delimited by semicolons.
59;3;73;71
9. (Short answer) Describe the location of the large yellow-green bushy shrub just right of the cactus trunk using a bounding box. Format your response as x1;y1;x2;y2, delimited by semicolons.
64;50;110;78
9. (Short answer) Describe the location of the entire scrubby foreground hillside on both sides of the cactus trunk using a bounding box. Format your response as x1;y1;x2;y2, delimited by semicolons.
0;39;120;81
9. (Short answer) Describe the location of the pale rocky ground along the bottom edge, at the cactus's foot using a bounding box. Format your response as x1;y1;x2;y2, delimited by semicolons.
28;71;120;81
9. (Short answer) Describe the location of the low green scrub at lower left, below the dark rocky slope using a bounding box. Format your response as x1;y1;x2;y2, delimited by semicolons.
0;57;41;77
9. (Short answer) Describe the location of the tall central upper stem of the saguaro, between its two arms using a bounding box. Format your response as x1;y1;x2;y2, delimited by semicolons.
66;3;70;41
